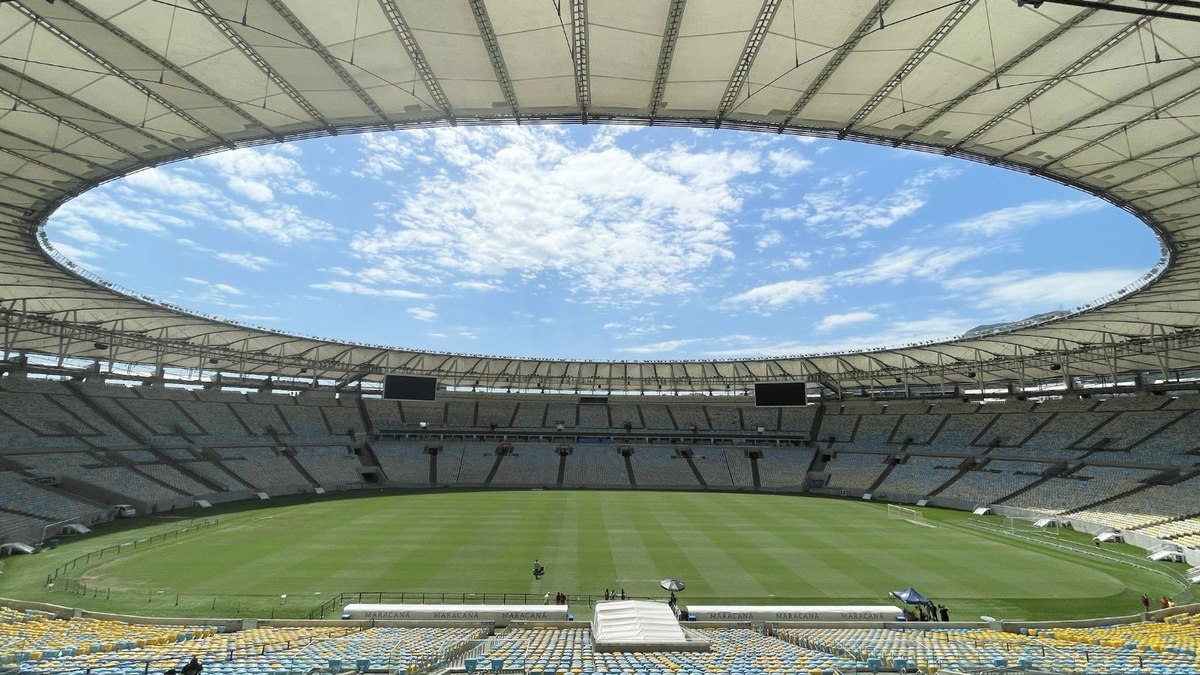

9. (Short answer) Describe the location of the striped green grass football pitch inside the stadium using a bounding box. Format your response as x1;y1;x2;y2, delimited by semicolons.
0;490;1190;621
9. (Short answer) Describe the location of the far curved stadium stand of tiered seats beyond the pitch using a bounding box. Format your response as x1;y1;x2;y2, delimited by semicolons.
0;377;1200;562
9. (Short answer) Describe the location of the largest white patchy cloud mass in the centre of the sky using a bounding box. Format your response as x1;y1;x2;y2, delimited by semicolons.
352;127;760;304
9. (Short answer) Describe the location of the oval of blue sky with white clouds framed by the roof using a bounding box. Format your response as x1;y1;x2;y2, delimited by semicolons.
47;126;1159;360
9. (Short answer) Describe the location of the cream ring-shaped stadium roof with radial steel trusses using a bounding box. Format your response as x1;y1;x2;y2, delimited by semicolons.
0;0;1200;390
